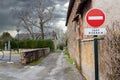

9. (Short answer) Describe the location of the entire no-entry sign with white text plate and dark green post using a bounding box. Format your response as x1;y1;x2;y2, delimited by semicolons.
84;9;106;80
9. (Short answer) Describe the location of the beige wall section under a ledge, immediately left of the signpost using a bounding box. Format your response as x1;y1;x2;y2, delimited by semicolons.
80;39;94;80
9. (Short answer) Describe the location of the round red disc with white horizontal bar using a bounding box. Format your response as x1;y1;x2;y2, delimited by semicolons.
86;9;105;28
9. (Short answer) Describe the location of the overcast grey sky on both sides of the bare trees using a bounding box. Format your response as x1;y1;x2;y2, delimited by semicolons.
0;0;69;36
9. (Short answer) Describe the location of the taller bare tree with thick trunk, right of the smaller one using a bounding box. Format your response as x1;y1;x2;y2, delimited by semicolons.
34;0;54;39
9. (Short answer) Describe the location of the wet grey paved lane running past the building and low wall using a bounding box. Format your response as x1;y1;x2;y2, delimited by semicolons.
0;52;84;80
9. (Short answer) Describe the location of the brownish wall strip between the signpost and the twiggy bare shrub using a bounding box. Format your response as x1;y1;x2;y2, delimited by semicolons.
98;40;106;80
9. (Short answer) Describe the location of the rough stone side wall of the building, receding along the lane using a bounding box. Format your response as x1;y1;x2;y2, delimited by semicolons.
67;0;80;67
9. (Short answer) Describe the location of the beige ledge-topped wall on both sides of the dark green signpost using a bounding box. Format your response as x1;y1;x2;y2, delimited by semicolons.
80;38;106;80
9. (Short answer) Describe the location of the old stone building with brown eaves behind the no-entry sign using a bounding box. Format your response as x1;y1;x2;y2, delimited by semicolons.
66;0;120;80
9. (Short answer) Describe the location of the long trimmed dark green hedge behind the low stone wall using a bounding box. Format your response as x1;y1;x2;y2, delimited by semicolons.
11;39;54;51
